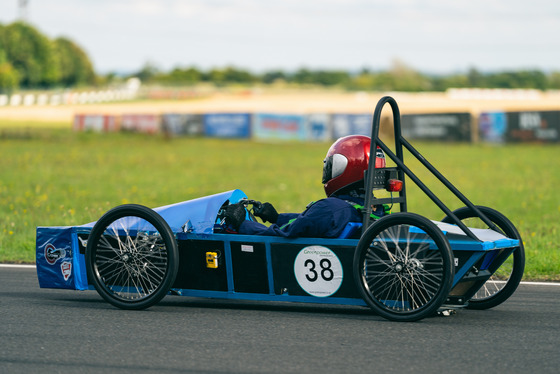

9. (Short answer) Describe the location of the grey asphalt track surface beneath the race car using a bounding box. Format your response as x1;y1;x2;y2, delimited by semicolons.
0;266;560;373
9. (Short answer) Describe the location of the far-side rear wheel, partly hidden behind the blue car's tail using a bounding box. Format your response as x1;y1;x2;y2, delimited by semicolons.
442;206;525;310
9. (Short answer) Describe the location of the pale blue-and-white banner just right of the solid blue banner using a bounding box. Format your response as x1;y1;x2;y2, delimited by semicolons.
253;113;305;140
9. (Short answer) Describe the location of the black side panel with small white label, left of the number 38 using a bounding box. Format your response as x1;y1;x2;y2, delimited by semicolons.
230;242;269;294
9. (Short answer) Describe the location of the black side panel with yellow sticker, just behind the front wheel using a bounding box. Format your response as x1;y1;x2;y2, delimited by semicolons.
172;240;227;291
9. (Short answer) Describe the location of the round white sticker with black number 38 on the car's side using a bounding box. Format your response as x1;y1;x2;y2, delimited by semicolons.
294;245;343;297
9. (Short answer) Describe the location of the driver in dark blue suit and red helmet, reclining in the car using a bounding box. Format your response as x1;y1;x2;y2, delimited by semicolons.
225;135;388;238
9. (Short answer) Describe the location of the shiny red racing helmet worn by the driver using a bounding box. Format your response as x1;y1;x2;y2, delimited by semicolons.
323;135;385;196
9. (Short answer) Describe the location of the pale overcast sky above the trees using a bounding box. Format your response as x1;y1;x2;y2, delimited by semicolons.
0;0;560;74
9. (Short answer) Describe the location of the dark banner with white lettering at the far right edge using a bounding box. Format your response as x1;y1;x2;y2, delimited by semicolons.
506;111;560;142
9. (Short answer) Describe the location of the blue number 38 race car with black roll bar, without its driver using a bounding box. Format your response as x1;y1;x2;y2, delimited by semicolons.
36;97;525;321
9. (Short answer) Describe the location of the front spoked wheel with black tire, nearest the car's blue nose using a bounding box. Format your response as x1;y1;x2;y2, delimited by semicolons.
86;204;179;309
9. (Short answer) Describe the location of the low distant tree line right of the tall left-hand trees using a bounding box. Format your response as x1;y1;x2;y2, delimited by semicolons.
134;61;560;92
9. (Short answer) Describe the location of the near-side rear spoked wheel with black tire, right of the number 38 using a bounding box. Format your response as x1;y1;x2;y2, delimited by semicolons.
353;213;455;322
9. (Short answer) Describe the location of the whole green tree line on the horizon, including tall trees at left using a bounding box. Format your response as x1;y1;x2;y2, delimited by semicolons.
0;22;560;93
